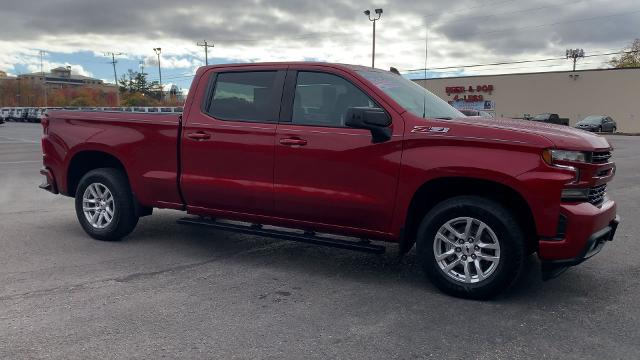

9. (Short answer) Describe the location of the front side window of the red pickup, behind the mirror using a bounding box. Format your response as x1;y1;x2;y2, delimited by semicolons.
291;71;378;127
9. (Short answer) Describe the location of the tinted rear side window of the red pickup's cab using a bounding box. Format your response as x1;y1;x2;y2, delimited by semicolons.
208;71;282;122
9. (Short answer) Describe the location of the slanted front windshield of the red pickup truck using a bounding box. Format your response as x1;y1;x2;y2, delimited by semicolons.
358;70;464;118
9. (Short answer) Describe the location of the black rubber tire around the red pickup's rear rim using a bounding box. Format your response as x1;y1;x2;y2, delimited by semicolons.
76;168;138;241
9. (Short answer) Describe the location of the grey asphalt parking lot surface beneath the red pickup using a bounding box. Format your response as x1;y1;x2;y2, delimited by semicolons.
0;123;640;359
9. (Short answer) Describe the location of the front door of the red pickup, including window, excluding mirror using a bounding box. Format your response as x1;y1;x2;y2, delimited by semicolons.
274;67;404;232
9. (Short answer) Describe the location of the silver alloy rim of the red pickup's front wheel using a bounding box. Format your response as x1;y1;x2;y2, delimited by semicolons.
433;217;500;283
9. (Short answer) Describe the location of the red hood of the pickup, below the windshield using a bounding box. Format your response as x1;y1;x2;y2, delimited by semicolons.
453;118;611;151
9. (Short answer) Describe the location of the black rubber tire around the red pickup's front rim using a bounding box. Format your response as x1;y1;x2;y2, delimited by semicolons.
416;196;526;299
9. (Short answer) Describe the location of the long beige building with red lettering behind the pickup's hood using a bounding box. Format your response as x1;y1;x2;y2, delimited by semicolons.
414;68;640;133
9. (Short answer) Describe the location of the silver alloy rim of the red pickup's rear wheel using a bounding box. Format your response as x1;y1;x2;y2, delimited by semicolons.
82;183;115;229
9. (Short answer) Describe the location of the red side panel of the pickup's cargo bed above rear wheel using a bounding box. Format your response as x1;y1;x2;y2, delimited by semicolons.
42;110;182;209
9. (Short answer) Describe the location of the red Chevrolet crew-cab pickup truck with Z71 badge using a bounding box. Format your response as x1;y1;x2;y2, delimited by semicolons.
41;63;618;298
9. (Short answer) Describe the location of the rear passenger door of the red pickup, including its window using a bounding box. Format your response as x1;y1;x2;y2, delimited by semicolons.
181;66;286;214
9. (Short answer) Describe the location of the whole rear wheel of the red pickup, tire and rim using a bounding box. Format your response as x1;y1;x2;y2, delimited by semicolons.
76;168;138;241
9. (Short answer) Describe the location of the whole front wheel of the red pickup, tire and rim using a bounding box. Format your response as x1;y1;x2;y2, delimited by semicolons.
416;196;526;299
